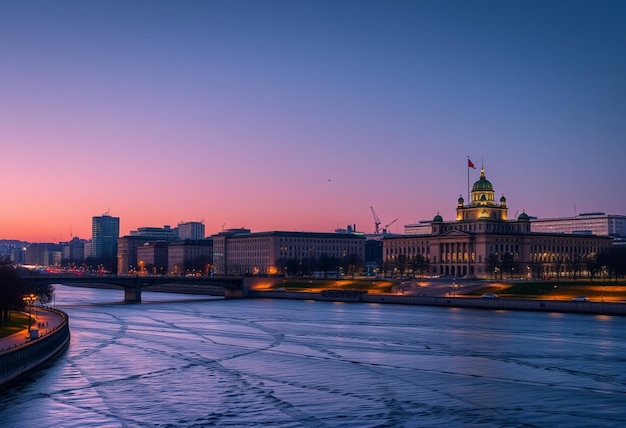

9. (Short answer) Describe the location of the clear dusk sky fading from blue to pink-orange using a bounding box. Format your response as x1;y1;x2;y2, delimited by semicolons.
0;0;626;242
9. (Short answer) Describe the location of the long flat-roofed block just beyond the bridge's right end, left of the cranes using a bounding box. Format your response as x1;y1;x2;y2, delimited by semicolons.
212;229;365;275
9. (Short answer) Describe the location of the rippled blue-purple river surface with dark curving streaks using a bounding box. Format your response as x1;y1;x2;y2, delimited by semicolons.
0;286;626;427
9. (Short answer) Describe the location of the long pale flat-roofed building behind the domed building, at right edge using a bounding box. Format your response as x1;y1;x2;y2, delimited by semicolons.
530;212;626;238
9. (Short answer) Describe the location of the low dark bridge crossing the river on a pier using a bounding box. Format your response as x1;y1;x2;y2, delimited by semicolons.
25;274;247;303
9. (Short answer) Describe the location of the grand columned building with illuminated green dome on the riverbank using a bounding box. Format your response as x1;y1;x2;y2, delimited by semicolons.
383;168;612;278
